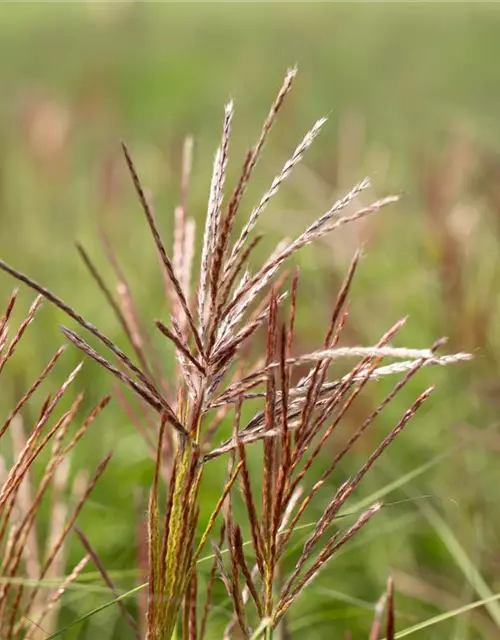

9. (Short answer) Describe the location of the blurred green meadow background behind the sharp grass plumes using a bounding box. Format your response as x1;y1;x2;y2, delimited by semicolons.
0;2;500;640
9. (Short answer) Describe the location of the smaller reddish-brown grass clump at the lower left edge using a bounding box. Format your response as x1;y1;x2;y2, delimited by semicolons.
0;291;110;640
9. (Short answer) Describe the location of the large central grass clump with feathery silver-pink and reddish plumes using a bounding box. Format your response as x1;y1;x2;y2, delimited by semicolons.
0;70;469;640
